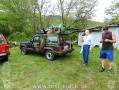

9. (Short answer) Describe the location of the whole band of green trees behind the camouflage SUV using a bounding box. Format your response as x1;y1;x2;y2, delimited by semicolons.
0;0;97;40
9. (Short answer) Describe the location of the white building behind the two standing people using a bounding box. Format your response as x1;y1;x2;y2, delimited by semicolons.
78;25;119;49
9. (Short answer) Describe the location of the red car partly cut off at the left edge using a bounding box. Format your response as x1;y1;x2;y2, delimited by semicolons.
0;33;10;61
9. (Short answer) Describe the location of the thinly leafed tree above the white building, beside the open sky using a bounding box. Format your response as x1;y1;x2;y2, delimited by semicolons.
73;0;97;29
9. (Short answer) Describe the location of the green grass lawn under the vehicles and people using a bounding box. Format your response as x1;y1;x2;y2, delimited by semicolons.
0;46;119;90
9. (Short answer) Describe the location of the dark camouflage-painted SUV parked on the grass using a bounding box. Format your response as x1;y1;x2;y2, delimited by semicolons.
20;33;73;60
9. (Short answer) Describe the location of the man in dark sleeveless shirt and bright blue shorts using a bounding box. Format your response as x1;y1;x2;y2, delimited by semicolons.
99;26;116;72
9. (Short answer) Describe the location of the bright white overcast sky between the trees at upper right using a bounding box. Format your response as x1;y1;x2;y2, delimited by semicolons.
51;0;114;22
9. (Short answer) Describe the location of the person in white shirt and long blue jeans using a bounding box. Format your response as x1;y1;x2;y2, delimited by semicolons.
81;30;92;65
